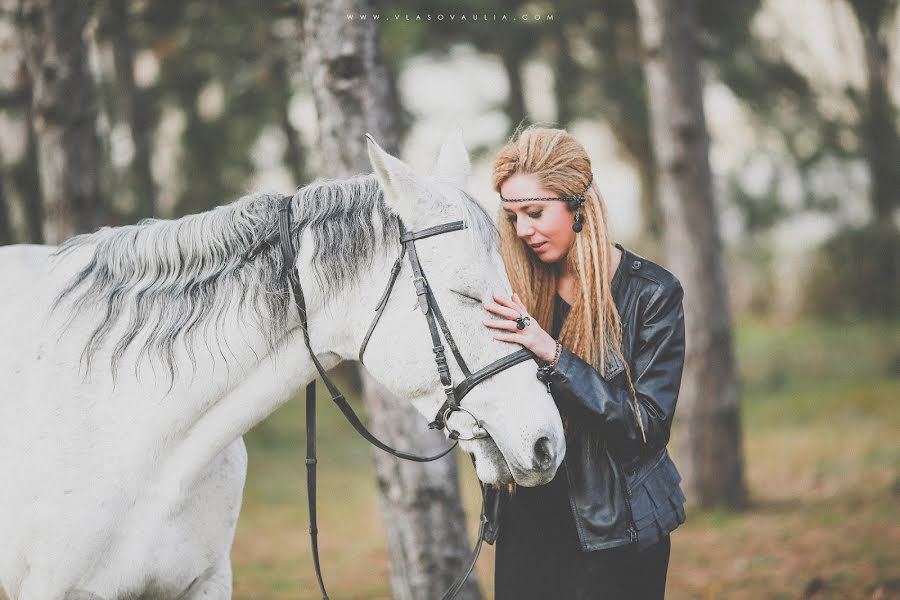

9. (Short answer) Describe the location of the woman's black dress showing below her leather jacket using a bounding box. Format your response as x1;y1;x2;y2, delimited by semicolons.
494;292;670;600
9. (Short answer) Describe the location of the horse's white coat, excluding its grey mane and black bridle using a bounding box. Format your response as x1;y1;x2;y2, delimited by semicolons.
0;135;564;600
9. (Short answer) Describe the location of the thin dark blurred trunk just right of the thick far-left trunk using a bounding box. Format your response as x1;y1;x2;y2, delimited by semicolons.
107;0;156;218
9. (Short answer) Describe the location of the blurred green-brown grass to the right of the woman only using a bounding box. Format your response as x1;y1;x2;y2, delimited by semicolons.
668;323;900;600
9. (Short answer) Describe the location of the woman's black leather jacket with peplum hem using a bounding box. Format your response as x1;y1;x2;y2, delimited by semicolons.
485;244;685;550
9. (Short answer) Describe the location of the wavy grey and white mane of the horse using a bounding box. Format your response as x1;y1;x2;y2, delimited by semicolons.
53;175;497;383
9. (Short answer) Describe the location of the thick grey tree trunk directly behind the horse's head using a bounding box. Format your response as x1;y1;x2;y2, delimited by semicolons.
301;0;481;600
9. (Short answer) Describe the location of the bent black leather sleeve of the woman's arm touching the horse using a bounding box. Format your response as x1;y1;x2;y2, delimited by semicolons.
551;280;684;455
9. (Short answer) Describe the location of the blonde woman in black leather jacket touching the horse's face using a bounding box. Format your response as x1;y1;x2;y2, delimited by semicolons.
485;127;685;600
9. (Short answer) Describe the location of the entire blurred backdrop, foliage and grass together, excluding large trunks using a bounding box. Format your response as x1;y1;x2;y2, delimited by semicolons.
0;0;900;598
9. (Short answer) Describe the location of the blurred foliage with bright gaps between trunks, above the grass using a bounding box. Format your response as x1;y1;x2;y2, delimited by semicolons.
0;0;900;319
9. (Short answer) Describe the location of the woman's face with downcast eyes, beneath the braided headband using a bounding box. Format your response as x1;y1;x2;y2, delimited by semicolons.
500;173;576;263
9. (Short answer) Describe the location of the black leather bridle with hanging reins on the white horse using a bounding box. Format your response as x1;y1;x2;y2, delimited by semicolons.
278;196;534;600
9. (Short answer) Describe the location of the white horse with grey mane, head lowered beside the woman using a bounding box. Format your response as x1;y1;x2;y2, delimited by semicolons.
0;135;565;600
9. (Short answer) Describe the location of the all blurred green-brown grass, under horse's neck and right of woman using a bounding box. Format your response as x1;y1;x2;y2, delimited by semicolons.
232;322;900;600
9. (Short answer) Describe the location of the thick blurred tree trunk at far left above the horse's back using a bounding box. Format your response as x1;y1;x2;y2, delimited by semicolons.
20;0;105;244
